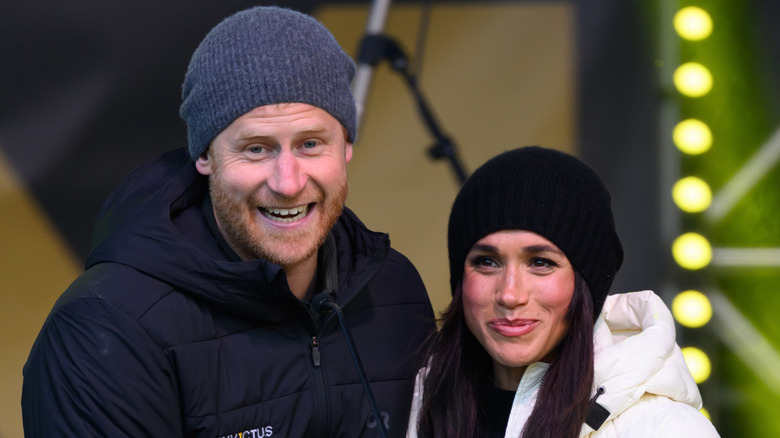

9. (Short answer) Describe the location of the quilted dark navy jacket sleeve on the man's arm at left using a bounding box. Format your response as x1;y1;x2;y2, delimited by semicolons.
22;298;182;438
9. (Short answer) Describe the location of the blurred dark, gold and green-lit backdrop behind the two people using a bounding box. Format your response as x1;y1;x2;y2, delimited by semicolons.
0;0;780;437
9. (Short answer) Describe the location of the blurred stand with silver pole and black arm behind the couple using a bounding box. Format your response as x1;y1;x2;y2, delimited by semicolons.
352;0;467;184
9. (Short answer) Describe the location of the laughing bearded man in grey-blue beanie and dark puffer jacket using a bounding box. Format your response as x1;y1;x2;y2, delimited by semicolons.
22;7;434;438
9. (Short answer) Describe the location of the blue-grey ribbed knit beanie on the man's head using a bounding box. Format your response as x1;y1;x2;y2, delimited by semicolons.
179;6;357;160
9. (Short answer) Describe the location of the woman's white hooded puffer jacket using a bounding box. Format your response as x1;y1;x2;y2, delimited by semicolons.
407;291;718;438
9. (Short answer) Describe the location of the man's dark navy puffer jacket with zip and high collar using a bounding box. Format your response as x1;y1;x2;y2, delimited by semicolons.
22;149;434;438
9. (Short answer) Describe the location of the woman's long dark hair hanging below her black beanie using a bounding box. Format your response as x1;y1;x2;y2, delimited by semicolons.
417;272;593;438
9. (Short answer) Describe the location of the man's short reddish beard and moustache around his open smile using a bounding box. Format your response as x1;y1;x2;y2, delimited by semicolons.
209;166;348;268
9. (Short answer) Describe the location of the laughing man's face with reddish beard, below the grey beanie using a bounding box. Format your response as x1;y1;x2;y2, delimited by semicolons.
196;103;352;268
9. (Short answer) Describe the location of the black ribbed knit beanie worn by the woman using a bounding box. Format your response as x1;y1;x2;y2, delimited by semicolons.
448;146;623;315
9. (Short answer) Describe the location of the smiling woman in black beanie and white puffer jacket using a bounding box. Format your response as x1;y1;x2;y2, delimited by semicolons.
407;147;718;438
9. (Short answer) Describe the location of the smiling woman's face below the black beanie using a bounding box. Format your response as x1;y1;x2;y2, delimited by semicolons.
463;230;574;390
